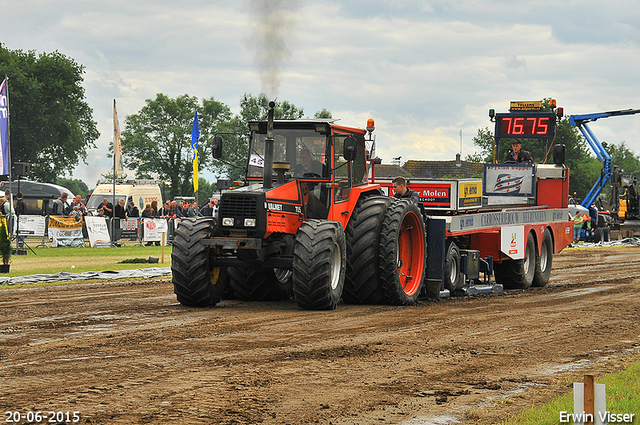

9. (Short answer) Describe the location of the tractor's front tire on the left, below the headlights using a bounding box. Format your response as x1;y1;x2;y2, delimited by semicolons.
171;218;227;307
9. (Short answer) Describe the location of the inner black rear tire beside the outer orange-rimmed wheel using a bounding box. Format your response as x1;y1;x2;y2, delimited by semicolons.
342;196;392;304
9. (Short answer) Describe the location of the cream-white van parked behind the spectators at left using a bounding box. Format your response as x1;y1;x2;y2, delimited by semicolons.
87;180;162;214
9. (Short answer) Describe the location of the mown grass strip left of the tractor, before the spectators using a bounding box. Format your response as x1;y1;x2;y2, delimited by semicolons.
0;246;171;277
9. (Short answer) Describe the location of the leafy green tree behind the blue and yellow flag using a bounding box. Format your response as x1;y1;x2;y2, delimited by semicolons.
122;93;232;198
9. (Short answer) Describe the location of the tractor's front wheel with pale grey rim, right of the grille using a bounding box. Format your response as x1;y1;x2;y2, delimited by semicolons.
293;219;347;310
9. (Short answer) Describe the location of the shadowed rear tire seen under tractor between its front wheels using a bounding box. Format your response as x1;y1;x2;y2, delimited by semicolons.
229;267;293;301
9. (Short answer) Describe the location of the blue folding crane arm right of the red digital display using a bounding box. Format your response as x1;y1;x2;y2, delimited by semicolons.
569;109;640;208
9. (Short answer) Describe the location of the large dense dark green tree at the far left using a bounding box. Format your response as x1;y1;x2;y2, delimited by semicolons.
0;43;100;182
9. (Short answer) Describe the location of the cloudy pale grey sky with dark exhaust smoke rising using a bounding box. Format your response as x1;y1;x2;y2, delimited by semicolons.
0;0;640;187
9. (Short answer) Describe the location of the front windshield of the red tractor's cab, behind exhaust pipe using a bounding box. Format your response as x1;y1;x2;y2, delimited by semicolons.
247;129;330;179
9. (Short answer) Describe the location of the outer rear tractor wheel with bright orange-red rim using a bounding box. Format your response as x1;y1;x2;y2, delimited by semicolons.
379;199;426;305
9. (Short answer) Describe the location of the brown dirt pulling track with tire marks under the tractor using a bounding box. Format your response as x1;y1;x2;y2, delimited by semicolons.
0;243;640;425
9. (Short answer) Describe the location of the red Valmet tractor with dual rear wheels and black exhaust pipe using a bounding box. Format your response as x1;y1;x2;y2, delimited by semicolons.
171;102;426;310
